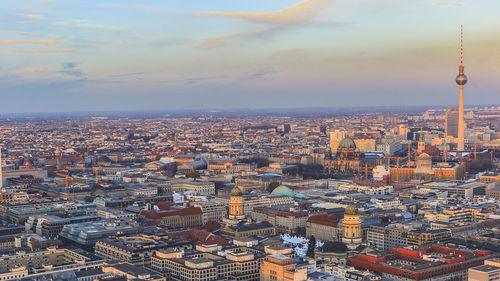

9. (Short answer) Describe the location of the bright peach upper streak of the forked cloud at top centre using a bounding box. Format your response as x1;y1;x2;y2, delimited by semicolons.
199;0;333;24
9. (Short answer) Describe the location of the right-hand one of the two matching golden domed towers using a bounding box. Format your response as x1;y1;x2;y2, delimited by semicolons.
342;197;363;250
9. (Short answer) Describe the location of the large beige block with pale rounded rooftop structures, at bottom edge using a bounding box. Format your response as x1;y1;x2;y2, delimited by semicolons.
151;244;265;281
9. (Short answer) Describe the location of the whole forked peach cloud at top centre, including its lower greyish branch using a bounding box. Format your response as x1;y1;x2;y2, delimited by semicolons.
195;0;334;49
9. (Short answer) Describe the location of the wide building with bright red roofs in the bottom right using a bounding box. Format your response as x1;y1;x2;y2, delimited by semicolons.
348;245;498;281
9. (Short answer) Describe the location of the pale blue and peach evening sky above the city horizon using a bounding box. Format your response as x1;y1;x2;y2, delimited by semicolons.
0;0;500;113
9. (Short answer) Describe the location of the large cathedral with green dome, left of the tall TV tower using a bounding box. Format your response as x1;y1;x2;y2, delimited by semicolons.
323;136;364;175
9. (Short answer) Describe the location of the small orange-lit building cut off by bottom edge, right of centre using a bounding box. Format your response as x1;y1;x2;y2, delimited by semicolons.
260;255;307;281
